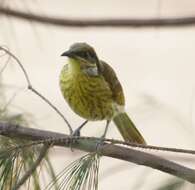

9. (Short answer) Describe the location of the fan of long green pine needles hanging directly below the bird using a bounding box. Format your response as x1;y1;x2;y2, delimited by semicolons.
45;153;100;190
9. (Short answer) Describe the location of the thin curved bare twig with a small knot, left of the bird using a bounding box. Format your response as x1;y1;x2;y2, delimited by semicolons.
0;46;73;134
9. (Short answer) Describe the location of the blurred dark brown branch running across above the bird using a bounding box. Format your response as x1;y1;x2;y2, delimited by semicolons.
0;7;195;28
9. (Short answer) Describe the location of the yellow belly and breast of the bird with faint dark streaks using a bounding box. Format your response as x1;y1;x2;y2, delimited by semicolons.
60;72;114;120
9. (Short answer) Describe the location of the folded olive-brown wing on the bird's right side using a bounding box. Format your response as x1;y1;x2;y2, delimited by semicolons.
100;61;125;106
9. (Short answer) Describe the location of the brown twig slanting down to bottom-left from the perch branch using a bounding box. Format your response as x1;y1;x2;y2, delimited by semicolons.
12;144;49;190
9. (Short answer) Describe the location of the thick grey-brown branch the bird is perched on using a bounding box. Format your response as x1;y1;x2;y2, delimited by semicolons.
0;123;195;183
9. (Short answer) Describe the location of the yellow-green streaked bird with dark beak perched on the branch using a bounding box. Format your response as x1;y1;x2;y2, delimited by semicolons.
59;42;146;145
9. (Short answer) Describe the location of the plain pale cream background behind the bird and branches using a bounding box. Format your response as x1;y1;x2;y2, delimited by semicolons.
0;0;195;190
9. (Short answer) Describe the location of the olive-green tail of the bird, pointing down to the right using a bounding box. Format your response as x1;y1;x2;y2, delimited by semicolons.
113;112;146;144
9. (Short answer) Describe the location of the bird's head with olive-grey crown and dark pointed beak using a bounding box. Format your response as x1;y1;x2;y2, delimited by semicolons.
61;43;99;67
